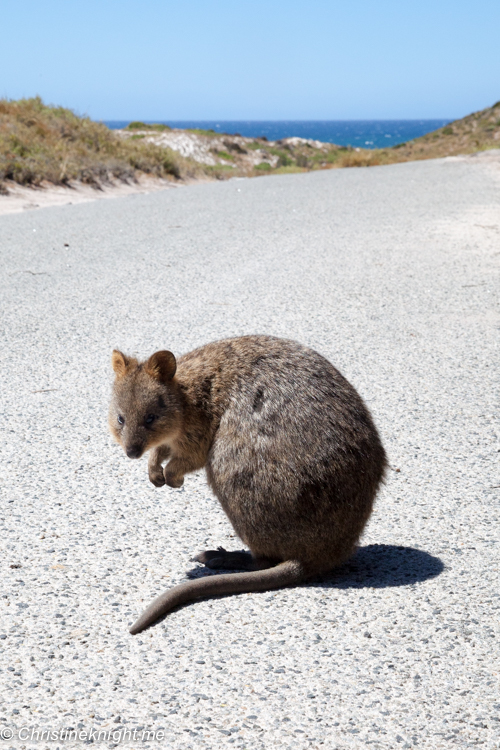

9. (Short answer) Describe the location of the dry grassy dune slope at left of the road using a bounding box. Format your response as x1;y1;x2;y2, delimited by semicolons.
0;97;203;192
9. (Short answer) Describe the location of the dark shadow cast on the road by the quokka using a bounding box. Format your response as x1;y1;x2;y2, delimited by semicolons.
187;544;444;589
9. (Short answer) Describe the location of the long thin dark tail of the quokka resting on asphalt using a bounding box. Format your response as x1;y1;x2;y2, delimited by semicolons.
130;560;306;635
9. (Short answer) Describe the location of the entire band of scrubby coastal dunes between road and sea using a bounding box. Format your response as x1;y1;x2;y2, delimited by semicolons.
0;97;500;193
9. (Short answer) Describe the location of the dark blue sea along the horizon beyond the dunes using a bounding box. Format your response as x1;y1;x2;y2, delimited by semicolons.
104;120;451;148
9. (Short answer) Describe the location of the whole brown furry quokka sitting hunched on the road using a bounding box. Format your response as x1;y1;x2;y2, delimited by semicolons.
109;336;386;633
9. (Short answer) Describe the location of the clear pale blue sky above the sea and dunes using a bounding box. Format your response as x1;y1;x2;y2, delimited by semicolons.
0;0;500;120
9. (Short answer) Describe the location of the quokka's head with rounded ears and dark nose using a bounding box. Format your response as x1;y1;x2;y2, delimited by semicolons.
109;349;182;458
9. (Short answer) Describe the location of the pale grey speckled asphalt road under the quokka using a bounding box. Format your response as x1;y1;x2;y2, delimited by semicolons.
0;160;500;750
